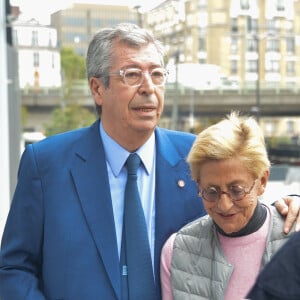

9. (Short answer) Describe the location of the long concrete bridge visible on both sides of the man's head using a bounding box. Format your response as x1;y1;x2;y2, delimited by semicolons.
21;81;300;123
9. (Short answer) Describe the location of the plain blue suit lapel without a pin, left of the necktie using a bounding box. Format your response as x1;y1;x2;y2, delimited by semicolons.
71;122;120;298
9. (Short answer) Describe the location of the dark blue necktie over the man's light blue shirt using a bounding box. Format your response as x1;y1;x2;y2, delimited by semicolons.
121;153;157;300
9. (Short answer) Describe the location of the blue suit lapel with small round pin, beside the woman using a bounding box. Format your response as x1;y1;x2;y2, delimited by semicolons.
155;129;196;278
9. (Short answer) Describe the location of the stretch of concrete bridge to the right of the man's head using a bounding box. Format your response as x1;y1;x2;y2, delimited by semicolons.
165;85;300;116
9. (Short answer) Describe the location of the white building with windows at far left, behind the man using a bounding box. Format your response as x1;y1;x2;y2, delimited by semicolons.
13;20;62;91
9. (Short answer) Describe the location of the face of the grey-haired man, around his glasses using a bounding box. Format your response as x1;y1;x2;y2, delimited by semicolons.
94;43;164;151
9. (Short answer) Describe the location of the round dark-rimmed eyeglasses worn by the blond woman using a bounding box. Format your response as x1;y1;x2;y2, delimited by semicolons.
198;179;257;202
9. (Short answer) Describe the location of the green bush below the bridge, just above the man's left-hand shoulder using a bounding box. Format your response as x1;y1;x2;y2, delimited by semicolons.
44;105;96;136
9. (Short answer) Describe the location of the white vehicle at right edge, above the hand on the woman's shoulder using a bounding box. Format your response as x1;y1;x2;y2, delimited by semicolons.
262;164;300;204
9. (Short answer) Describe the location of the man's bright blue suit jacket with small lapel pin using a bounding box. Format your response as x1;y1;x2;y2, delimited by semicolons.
0;121;205;300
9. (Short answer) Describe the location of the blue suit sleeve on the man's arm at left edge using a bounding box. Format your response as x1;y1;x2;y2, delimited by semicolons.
0;145;45;300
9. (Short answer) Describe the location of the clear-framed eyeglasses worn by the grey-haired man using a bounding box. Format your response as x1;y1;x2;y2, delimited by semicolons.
109;68;168;87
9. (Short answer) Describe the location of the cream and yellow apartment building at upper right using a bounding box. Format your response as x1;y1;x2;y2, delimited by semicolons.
144;0;300;88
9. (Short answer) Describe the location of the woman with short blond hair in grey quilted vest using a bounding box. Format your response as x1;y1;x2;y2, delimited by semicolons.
161;112;294;300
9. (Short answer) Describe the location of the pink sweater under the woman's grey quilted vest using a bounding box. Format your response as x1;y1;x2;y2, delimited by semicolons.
160;210;270;300
